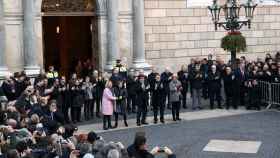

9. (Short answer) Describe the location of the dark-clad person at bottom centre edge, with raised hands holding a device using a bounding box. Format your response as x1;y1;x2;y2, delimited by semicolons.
127;132;176;158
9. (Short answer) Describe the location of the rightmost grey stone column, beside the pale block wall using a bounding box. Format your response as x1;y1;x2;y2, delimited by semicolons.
133;0;151;70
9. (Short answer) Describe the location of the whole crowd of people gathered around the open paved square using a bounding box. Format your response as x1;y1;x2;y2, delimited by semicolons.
0;53;280;158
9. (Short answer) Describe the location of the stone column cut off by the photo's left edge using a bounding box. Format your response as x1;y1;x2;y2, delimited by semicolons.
0;0;8;79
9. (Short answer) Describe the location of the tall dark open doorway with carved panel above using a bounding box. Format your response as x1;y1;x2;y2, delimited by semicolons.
42;0;99;76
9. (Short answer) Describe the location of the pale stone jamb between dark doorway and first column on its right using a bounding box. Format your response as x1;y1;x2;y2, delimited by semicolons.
94;0;108;71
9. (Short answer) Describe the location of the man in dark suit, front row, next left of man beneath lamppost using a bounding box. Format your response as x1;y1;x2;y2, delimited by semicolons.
208;65;222;109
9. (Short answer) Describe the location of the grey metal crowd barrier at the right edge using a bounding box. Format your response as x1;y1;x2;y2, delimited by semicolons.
258;81;280;109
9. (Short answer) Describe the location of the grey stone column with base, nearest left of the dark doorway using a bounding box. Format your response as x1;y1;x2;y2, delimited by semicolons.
22;0;40;76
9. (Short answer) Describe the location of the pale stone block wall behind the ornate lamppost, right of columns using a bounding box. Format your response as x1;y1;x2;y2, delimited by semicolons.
145;0;280;70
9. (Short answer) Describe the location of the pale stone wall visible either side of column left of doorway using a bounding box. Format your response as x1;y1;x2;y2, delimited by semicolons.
3;0;43;72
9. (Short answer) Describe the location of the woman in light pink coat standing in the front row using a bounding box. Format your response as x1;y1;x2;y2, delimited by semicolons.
102;81;116;130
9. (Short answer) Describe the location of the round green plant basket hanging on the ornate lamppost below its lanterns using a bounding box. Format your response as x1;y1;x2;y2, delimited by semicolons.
221;32;247;52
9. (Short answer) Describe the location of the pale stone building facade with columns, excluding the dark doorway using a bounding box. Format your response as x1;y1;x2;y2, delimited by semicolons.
0;0;280;76
